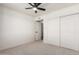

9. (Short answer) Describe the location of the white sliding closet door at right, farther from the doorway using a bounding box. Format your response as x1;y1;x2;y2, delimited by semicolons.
60;15;79;50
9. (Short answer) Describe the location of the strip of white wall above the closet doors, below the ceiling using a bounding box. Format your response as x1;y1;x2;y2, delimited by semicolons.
40;4;79;20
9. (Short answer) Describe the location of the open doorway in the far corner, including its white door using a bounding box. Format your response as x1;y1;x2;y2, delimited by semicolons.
35;21;43;40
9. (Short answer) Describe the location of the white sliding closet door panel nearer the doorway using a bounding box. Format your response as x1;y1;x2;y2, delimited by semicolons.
47;18;59;45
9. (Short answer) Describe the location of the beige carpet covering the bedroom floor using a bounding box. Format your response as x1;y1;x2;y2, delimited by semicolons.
0;41;79;55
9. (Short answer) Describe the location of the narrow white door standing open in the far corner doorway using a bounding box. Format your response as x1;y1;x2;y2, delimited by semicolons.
35;22;41;40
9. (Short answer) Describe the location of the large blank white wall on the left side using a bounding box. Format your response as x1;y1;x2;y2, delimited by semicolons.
0;7;34;50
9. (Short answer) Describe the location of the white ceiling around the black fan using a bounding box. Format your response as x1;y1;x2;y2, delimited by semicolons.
3;3;76;17
